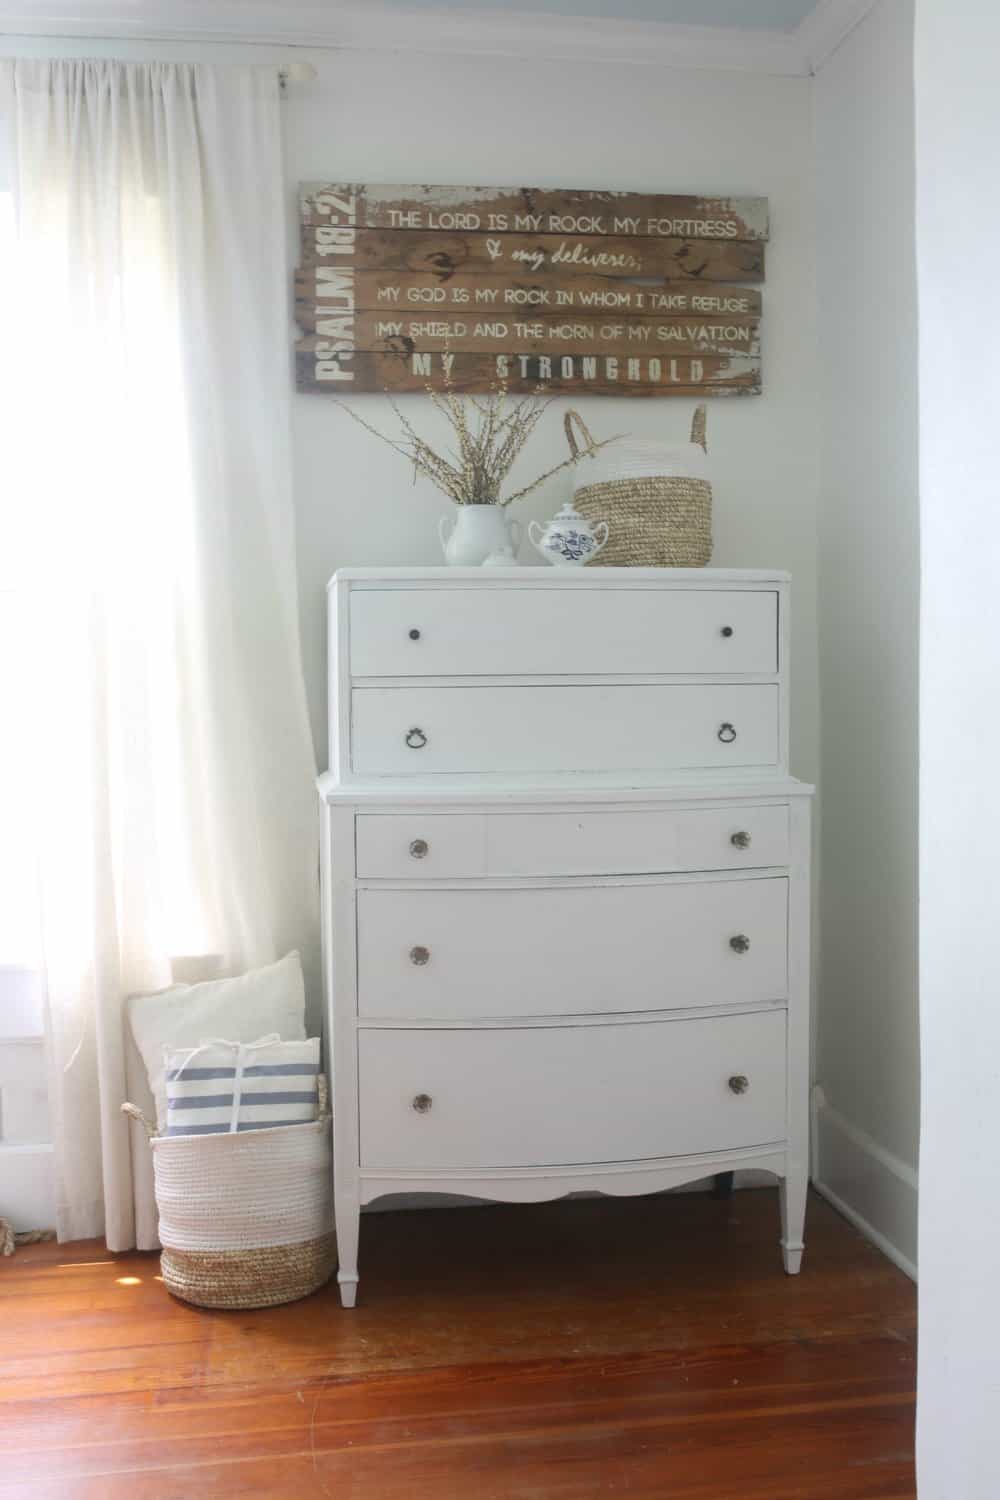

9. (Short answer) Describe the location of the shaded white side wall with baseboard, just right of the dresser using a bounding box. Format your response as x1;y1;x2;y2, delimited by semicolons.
816;0;919;1268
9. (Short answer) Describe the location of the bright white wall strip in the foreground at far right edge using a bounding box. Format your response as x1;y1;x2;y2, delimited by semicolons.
915;0;1000;1500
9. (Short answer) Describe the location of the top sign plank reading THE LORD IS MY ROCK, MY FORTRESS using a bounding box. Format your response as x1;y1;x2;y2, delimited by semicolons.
300;183;768;240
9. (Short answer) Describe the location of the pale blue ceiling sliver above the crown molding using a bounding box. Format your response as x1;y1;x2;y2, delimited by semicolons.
367;0;819;32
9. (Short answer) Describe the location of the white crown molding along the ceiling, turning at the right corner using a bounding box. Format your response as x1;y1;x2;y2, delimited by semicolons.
0;0;876;77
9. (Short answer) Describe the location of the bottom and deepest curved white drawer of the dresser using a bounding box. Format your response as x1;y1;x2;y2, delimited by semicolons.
358;1011;786;1172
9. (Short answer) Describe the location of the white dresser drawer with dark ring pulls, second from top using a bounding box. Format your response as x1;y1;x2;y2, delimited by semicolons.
351;683;778;776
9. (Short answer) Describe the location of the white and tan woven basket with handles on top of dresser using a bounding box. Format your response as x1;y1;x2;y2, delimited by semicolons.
564;405;712;567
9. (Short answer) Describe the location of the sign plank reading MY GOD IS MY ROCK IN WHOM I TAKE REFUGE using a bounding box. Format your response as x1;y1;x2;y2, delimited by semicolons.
295;264;762;318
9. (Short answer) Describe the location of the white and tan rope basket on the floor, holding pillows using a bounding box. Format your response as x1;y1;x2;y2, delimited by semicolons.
121;1079;337;1308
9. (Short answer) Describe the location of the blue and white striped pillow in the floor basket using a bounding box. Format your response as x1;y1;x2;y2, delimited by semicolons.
163;1037;319;1136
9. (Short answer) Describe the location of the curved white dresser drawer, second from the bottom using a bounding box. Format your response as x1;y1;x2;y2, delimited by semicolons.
358;878;787;1022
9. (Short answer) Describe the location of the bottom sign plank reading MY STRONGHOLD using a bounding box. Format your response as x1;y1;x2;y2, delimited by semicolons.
295;346;760;396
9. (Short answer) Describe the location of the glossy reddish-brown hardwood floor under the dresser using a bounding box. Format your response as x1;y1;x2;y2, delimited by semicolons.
0;1190;916;1500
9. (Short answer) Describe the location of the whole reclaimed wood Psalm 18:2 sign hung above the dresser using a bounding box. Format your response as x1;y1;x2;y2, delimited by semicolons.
295;183;768;396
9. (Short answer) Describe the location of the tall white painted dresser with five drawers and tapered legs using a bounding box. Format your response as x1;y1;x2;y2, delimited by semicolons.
319;569;813;1307
